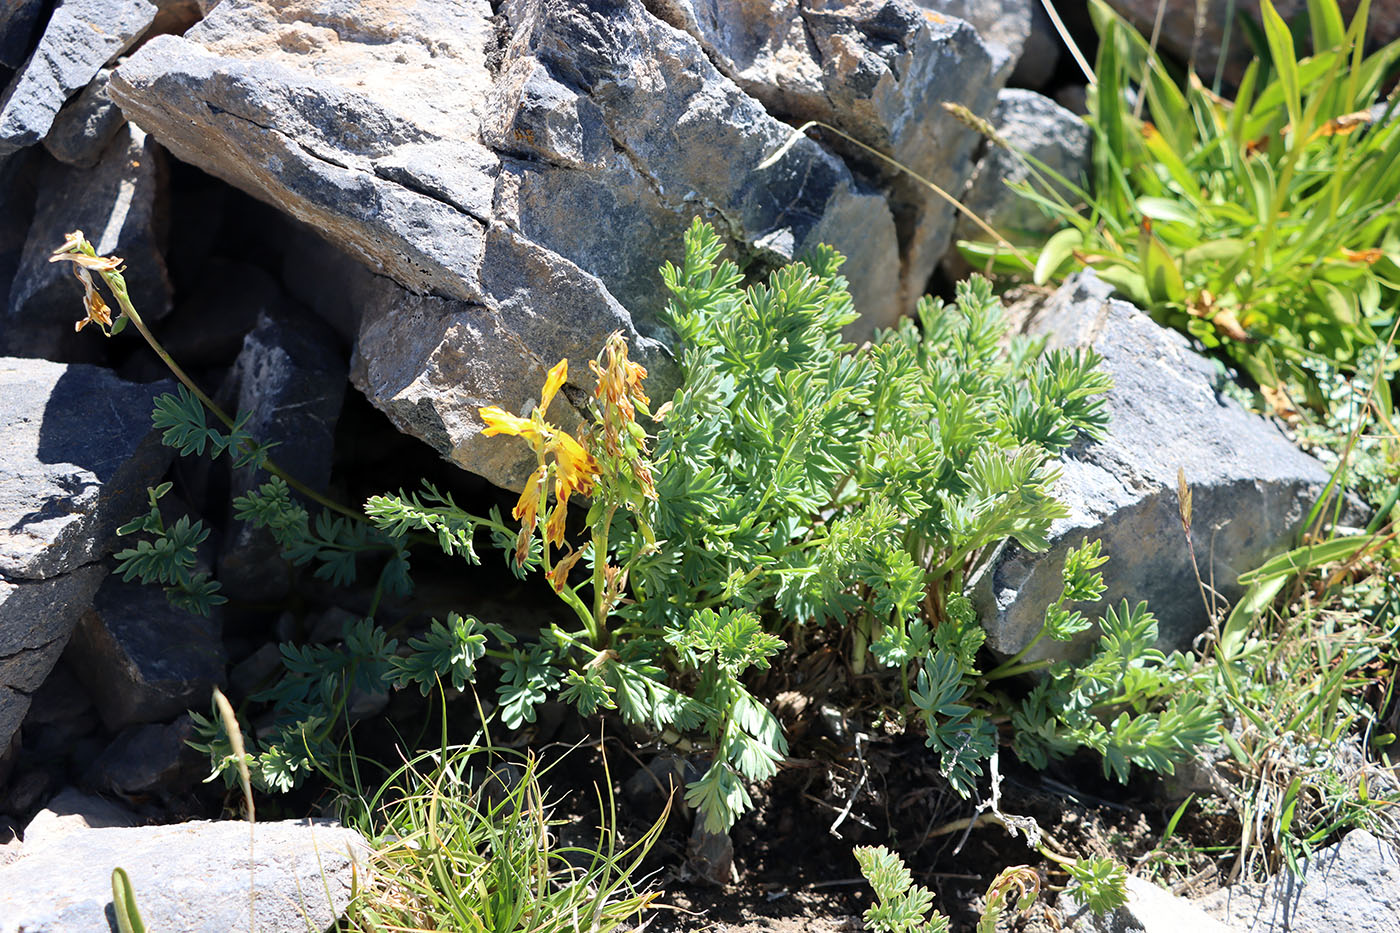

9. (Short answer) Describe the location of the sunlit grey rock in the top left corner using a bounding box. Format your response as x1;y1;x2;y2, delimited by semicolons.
0;0;155;157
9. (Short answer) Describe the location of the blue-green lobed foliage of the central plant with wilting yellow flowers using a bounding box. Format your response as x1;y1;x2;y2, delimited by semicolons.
150;215;1215;831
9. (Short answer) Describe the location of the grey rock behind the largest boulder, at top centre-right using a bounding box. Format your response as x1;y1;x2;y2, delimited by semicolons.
652;0;996;319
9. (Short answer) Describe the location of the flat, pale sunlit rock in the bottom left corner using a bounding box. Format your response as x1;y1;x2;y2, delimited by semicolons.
0;820;367;933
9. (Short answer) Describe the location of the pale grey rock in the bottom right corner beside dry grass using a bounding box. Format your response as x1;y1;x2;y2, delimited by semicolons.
1201;829;1400;933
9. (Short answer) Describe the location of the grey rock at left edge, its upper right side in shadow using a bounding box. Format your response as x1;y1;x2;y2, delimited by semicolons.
0;357;174;748
